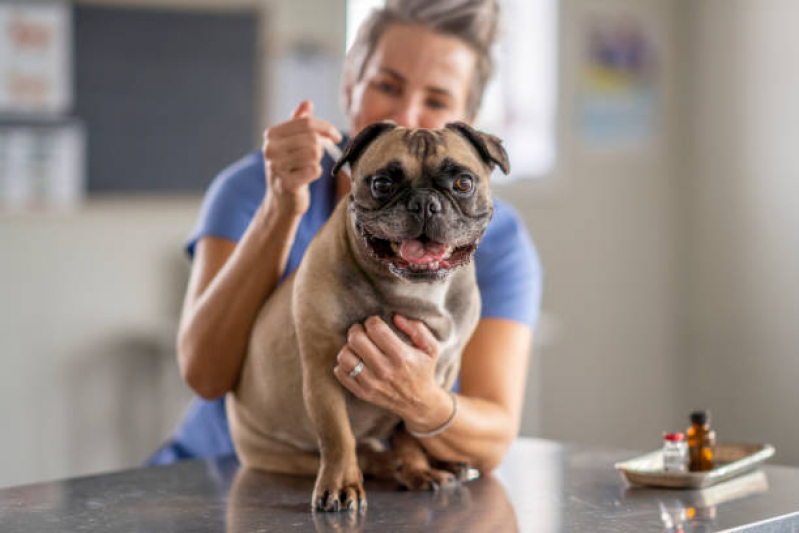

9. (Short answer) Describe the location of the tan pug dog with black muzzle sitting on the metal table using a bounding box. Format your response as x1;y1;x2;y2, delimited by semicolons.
227;122;508;511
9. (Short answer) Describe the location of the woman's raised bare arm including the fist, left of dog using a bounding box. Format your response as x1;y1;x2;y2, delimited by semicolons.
178;101;341;399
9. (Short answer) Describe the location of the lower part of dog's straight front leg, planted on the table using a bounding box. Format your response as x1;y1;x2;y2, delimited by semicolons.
303;362;366;511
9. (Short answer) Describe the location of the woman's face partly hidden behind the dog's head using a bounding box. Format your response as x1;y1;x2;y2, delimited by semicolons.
348;24;476;135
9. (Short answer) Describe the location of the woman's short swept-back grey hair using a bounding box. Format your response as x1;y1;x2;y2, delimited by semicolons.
344;0;499;118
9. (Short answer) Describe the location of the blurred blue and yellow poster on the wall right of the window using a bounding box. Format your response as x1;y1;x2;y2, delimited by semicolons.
577;12;658;151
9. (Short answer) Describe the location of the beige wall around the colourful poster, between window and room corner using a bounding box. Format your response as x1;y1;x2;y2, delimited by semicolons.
506;0;683;449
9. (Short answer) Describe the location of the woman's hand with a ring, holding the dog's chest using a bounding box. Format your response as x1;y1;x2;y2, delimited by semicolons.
333;315;452;431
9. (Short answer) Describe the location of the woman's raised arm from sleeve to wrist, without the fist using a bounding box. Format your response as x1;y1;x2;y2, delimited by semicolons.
178;206;298;399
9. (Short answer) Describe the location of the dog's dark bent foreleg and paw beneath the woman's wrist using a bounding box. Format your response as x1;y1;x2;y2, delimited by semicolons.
391;429;458;490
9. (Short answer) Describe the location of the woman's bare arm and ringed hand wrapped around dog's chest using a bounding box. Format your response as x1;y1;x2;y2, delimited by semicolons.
334;317;532;471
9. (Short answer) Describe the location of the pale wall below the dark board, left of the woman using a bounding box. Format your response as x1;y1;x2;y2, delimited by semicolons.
0;198;197;486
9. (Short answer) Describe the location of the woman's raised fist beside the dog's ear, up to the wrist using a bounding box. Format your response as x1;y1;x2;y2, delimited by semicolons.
263;100;342;216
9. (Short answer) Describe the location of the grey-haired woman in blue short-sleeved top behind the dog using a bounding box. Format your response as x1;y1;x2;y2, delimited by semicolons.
151;0;540;470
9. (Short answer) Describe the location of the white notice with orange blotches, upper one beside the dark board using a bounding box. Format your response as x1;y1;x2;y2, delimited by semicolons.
0;0;72;118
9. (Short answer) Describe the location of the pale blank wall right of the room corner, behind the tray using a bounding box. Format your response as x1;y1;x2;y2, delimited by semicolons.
683;0;799;464
